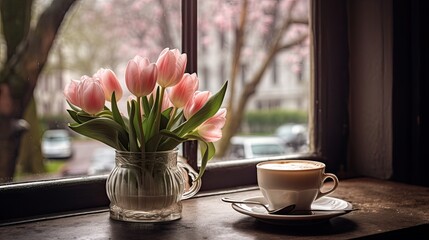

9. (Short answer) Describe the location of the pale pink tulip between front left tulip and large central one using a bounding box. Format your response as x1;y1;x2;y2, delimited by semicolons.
93;68;122;102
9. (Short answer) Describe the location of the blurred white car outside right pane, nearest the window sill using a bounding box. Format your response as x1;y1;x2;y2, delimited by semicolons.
226;136;286;159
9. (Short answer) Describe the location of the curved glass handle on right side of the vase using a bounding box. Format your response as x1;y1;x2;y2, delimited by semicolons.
177;157;201;199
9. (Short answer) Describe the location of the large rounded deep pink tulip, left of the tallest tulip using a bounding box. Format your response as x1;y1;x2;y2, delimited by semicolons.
125;56;158;97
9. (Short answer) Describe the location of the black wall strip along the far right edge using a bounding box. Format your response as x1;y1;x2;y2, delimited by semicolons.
392;0;429;186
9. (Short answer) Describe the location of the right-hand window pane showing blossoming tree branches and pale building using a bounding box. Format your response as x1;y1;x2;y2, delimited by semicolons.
198;0;310;162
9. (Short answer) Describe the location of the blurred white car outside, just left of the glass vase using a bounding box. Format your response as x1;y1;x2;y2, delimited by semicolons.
88;147;115;175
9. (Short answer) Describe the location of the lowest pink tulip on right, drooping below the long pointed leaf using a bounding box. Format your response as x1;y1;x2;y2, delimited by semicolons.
198;108;226;142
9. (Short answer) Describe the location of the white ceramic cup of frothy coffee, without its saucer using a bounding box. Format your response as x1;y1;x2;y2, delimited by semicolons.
256;160;339;210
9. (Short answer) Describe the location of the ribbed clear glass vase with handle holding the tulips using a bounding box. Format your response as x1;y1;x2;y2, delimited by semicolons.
106;149;201;222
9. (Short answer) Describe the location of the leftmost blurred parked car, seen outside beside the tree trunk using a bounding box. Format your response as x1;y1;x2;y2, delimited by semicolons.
42;129;73;159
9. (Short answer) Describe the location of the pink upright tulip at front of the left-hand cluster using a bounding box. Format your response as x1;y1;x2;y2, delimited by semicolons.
78;76;105;114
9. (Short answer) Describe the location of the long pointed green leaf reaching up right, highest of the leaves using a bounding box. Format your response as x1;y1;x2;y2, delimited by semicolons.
174;82;228;136
